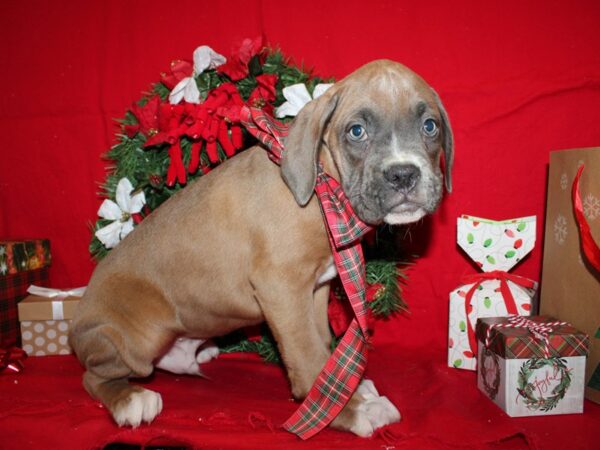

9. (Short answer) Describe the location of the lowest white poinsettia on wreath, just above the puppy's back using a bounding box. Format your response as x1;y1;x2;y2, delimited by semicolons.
95;178;146;248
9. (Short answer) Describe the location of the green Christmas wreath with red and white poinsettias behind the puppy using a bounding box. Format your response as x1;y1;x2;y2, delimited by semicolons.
90;38;406;361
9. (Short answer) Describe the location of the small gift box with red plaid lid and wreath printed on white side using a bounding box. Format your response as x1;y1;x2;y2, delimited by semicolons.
476;316;589;417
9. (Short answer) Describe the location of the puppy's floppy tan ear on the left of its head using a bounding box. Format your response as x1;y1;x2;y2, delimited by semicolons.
281;92;338;206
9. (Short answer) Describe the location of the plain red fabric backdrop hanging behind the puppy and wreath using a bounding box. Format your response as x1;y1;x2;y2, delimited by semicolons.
0;0;600;448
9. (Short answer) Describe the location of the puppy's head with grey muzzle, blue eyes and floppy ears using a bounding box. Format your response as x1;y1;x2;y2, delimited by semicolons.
281;61;454;225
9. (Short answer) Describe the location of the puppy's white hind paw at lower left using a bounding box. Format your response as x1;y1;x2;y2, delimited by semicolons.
112;389;162;428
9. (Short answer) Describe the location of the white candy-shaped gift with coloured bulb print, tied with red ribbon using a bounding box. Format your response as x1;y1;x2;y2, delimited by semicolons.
448;215;537;370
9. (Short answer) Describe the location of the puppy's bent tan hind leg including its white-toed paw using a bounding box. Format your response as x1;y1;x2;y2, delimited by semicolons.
70;282;176;427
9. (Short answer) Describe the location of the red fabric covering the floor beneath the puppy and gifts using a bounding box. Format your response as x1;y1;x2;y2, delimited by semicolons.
0;346;600;450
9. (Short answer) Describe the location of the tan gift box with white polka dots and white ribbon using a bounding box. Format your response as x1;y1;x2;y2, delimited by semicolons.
19;286;83;356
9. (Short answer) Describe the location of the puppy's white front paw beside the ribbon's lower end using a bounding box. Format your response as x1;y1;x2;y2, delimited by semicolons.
333;380;400;437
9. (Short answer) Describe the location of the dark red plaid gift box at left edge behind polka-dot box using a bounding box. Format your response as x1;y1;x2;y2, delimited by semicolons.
0;239;51;348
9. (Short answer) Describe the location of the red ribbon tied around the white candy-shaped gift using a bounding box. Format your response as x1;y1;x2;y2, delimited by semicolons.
461;270;535;355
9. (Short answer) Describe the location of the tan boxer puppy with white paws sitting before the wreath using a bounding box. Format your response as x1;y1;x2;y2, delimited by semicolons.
70;61;453;436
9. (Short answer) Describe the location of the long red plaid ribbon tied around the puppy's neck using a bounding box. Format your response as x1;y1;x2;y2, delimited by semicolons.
241;106;371;439
